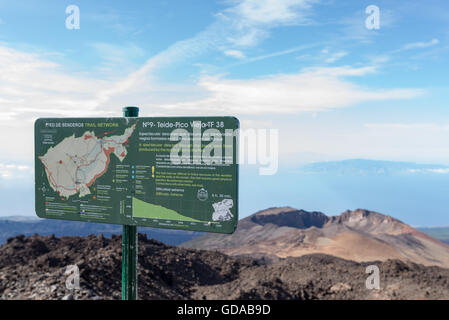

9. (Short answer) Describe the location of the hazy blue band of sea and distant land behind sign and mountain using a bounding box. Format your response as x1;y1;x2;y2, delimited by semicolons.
0;159;449;228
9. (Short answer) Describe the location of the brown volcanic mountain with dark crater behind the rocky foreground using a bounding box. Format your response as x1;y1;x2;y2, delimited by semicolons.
182;207;449;268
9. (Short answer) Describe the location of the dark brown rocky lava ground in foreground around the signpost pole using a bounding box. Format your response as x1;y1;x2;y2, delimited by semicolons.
0;235;449;299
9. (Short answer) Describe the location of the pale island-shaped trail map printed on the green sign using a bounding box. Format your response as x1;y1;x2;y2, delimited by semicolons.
39;124;136;199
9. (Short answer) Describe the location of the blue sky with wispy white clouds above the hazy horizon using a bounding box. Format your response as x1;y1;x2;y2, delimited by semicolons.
0;0;449;222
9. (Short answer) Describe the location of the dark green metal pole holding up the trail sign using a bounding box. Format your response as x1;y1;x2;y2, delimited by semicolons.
122;107;139;300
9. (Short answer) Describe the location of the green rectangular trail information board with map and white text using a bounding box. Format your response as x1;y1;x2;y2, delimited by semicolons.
35;117;239;233
